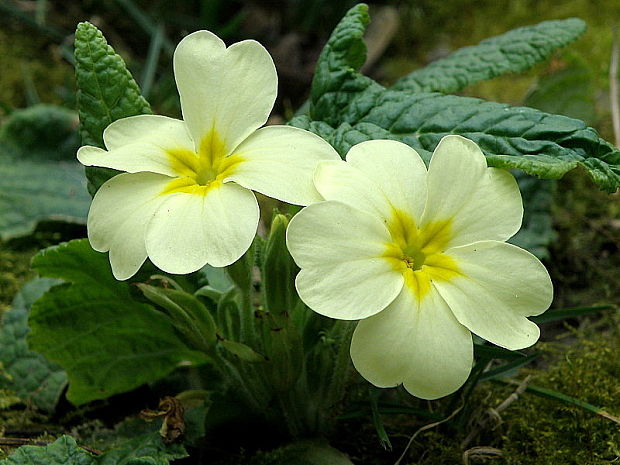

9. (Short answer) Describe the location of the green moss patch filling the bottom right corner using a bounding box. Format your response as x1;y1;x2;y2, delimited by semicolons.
500;317;620;465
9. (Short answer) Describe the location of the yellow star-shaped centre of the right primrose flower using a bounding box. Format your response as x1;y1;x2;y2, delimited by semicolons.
383;209;460;301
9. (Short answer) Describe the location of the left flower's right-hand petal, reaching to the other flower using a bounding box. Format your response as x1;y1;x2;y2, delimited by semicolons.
227;126;340;205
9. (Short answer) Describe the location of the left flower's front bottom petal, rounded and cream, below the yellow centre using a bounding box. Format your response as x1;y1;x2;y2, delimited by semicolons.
146;183;259;274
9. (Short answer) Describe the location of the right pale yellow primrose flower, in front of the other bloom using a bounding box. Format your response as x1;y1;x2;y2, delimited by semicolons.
287;136;553;399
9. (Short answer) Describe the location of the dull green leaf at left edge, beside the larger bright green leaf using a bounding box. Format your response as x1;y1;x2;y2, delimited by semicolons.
0;278;67;412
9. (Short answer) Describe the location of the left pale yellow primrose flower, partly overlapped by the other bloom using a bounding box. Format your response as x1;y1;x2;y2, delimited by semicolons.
78;31;340;279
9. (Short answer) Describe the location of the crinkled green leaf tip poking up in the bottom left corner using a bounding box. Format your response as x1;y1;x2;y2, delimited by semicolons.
0;436;97;465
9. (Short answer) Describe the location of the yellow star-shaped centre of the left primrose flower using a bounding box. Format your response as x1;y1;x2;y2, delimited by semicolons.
162;129;243;195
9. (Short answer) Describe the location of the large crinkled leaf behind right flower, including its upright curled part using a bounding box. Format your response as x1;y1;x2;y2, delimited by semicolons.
291;5;620;192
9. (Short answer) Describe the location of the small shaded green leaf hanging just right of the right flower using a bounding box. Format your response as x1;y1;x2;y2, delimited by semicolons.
508;172;556;260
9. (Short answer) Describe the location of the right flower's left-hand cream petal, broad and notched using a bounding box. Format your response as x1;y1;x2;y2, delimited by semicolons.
287;201;403;320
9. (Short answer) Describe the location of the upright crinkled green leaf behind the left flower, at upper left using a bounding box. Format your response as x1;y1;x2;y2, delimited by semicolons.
75;22;151;195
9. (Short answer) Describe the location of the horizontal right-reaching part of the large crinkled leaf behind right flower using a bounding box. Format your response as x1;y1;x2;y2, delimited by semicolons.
291;89;620;192
